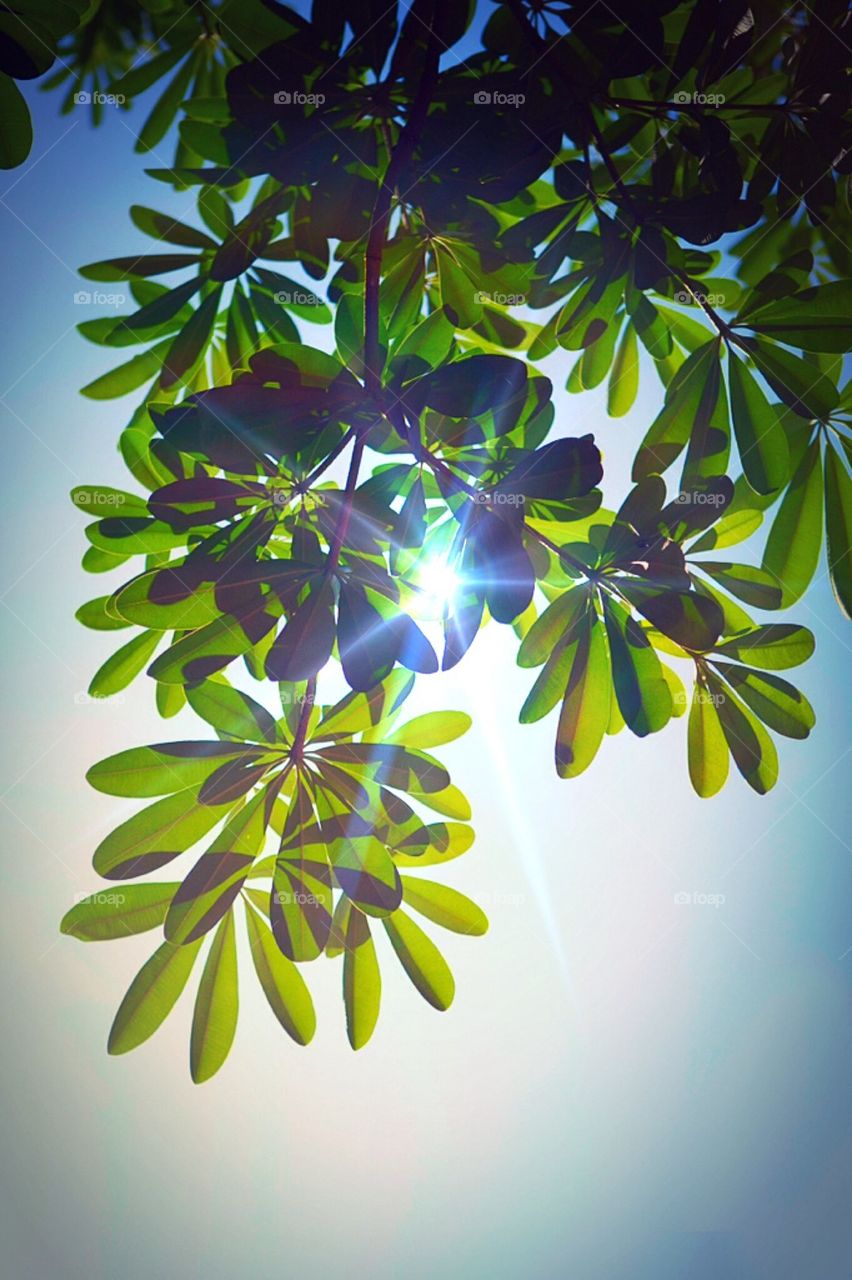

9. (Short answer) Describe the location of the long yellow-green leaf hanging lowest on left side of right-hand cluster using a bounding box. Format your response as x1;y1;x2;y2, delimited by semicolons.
555;611;611;778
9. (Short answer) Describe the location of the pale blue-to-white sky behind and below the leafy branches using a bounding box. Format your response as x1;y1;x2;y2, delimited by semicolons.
0;10;852;1280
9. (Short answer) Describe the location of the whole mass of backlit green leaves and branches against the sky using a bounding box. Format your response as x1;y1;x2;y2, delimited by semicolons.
1;0;852;1082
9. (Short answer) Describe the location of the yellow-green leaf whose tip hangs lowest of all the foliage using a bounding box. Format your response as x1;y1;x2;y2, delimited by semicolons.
189;911;239;1084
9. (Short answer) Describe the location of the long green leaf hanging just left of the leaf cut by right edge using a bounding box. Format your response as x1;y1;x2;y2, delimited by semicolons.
762;436;823;608
